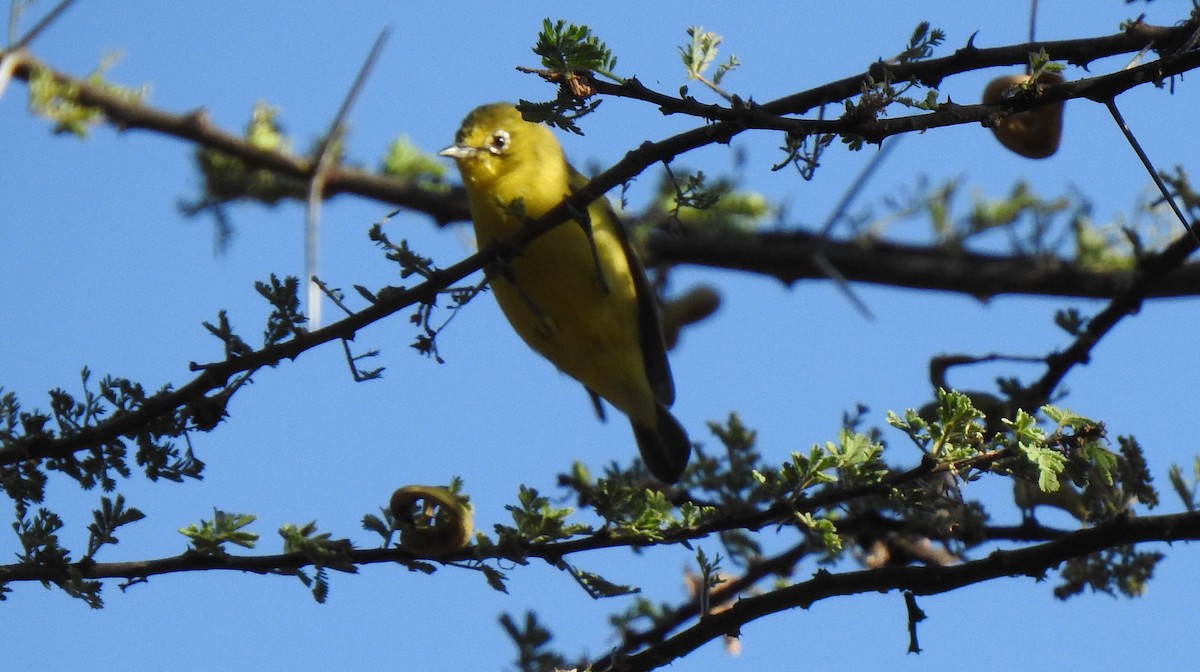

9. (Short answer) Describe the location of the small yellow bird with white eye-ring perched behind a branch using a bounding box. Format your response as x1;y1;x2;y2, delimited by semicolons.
440;103;691;482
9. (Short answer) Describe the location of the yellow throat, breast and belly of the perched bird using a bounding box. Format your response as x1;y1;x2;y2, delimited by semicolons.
453;127;656;426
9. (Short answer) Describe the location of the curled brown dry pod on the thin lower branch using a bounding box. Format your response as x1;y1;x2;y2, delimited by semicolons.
390;485;475;557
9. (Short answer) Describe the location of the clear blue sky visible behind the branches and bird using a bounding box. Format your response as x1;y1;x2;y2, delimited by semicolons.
0;0;1200;670
